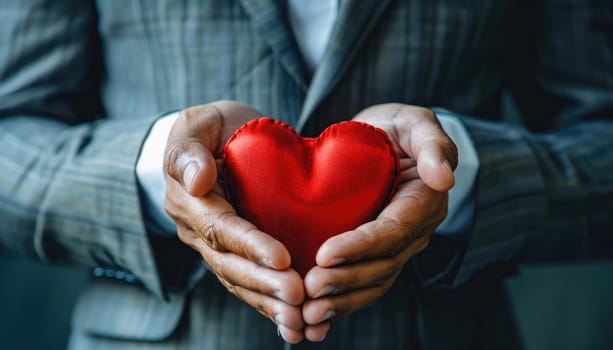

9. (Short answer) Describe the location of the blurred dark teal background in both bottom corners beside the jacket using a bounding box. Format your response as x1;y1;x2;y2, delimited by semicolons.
0;256;613;350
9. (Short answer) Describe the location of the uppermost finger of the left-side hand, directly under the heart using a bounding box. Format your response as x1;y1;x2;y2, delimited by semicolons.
165;179;291;270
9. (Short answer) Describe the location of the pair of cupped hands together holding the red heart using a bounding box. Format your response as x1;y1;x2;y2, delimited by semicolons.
165;101;457;343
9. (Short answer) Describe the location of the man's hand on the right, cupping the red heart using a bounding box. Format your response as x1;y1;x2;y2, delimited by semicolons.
302;104;458;341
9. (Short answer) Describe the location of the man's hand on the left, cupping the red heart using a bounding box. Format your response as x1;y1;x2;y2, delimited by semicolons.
165;101;304;343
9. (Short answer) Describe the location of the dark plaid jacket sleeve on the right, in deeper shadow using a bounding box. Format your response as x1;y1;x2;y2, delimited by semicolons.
454;0;613;284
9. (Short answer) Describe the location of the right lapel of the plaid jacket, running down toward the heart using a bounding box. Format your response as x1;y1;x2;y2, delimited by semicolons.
296;0;390;130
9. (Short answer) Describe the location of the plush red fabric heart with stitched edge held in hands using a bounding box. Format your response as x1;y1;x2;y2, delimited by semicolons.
224;118;399;276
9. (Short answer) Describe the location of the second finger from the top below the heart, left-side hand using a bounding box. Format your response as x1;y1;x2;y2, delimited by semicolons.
197;238;304;306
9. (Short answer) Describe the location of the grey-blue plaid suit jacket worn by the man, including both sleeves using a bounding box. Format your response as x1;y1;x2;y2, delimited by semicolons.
0;0;613;349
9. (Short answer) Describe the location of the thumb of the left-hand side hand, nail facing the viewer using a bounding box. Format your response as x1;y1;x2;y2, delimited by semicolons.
165;139;217;197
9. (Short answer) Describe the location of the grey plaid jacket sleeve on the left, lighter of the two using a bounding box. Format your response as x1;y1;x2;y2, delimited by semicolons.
0;0;167;295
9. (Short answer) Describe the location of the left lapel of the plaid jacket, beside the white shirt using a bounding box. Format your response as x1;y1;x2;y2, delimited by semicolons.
240;0;308;91
